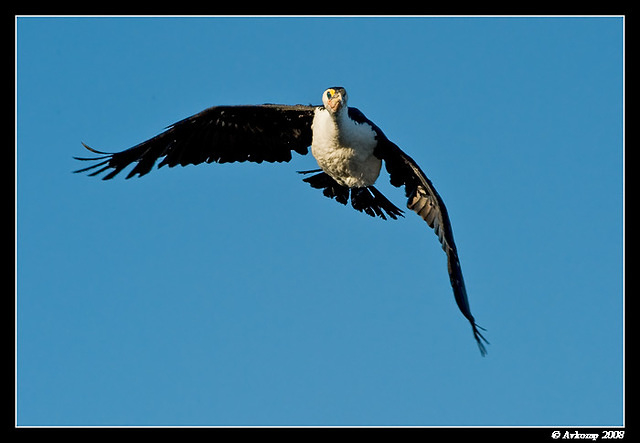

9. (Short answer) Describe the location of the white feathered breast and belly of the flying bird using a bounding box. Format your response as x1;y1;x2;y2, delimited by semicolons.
311;108;382;188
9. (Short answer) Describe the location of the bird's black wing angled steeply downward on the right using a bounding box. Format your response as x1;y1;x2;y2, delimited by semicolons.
375;137;489;355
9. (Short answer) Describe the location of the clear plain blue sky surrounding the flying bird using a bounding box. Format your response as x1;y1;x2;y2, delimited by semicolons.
16;17;624;426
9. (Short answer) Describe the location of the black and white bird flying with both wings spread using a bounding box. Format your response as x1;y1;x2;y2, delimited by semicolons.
74;87;488;356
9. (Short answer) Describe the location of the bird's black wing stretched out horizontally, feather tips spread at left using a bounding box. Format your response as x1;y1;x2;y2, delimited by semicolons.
74;105;315;180
